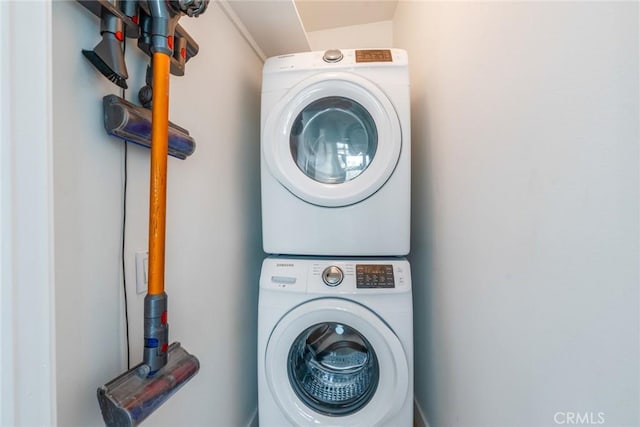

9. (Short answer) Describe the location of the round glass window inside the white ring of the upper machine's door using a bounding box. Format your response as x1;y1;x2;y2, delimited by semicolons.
289;96;378;184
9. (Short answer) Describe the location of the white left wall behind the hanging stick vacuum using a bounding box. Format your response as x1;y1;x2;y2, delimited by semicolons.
53;2;263;426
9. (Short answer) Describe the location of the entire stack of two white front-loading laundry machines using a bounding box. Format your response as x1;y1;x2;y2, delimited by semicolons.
258;49;413;427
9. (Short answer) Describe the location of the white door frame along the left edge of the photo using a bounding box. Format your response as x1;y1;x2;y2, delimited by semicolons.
0;0;56;426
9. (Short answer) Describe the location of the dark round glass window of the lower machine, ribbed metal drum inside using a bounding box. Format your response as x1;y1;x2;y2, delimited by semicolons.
287;322;380;416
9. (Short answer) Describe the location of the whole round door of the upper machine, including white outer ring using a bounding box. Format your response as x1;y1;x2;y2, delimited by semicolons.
262;73;402;207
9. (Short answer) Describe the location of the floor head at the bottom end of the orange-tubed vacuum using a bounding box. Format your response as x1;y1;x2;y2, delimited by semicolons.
98;342;200;427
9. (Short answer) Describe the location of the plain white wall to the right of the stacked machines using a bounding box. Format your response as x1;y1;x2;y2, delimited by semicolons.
394;2;640;427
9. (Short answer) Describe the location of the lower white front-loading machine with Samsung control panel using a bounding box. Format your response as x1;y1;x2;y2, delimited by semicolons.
258;257;413;427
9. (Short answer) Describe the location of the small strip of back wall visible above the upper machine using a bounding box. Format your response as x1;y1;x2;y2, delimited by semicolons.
307;21;393;50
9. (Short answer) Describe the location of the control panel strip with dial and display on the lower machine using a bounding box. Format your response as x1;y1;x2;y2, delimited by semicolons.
260;256;411;294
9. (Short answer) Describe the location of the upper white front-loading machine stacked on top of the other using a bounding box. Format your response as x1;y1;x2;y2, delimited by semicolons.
261;49;411;256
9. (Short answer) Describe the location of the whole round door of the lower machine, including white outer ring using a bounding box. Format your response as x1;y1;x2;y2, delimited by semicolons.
265;298;409;427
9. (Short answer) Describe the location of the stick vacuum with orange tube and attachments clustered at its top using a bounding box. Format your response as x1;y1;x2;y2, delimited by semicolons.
81;0;208;426
